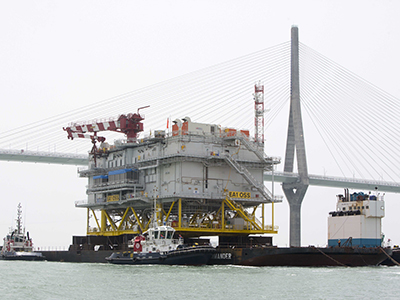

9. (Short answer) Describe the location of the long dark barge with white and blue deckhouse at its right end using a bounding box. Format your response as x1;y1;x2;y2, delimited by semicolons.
42;189;394;267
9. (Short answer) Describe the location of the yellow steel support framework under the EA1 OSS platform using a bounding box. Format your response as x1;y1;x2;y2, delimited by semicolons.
87;196;278;237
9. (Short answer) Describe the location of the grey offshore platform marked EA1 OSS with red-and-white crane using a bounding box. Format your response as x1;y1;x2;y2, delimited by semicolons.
64;84;282;250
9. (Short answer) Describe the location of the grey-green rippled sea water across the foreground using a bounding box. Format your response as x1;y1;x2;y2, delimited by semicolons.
0;261;400;300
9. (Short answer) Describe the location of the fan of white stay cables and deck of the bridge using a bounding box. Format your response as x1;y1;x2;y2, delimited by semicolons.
0;26;400;245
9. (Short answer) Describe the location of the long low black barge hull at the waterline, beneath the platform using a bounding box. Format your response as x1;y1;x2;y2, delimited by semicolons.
41;247;391;267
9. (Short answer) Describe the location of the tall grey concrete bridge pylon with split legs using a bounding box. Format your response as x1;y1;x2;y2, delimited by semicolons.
282;26;309;247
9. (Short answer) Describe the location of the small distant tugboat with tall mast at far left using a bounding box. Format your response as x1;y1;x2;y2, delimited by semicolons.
0;203;45;260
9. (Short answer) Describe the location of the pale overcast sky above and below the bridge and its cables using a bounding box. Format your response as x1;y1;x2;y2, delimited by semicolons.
0;0;400;247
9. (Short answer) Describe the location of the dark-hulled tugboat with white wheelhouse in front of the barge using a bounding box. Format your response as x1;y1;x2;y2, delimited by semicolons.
106;226;216;265
